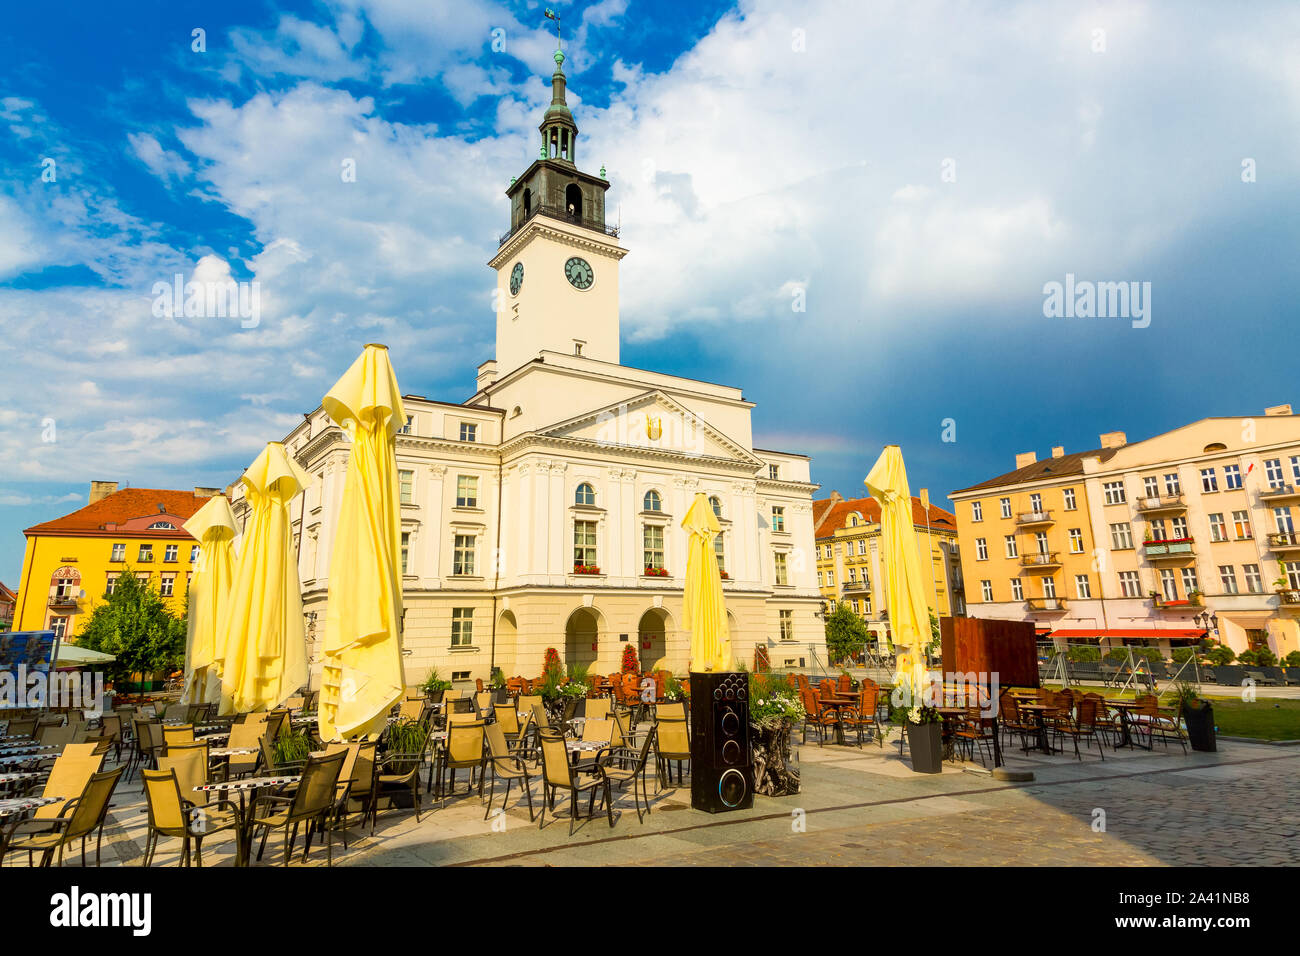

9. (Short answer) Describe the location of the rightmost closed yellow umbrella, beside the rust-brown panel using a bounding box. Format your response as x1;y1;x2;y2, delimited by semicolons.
865;445;931;706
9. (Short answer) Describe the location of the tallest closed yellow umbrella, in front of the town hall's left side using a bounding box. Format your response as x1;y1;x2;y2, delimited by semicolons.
320;345;406;740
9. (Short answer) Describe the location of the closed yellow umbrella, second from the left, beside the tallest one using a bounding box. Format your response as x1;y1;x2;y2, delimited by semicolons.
217;441;311;714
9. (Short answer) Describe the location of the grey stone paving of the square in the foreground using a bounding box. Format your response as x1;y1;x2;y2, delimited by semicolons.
5;741;1300;866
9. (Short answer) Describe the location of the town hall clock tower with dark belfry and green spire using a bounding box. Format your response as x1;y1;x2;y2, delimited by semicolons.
488;49;627;375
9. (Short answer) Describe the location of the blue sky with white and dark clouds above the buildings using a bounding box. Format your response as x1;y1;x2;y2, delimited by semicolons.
0;0;1300;583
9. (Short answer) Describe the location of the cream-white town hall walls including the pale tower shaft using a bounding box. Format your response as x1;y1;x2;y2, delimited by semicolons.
235;57;824;683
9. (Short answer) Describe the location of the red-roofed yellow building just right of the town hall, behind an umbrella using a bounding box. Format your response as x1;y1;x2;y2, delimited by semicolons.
813;492;965;647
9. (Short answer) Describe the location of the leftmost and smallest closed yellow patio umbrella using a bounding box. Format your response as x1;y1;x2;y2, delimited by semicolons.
181;494;239;704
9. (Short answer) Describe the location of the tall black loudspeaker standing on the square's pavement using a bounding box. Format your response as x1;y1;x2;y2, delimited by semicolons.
690;671;754;813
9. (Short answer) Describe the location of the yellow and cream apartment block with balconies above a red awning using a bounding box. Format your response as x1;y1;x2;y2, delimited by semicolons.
949;405;1300;657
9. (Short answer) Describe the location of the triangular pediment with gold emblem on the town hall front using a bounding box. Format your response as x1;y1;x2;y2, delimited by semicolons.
538;389;762;468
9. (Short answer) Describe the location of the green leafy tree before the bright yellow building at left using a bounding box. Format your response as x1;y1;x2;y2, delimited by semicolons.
77;572;186;680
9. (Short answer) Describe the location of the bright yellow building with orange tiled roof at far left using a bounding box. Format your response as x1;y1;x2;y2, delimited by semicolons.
13;481;218;639
